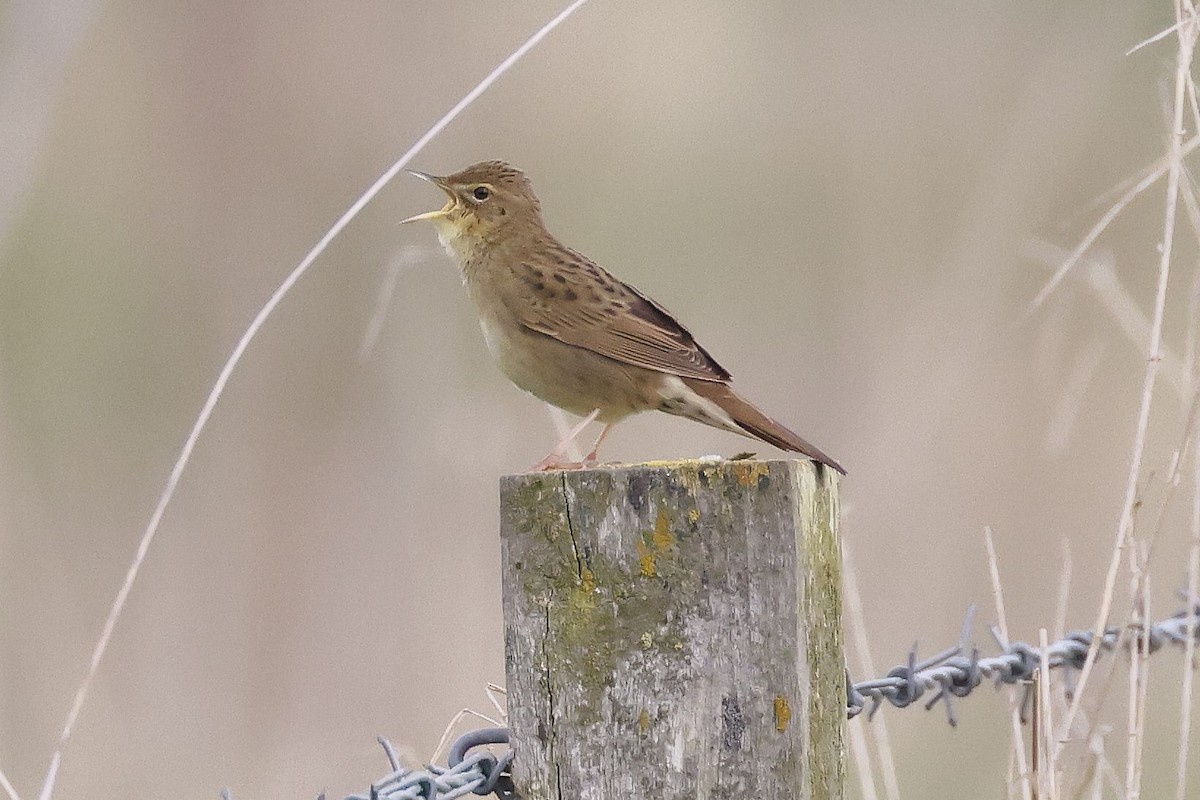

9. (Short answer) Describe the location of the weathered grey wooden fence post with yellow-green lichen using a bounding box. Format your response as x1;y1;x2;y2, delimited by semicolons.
500;461;846;800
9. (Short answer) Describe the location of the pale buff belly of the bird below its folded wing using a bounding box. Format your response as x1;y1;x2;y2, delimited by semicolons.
480;315;659;422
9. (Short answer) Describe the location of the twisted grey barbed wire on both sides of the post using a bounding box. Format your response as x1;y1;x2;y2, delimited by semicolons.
345;599;1200;800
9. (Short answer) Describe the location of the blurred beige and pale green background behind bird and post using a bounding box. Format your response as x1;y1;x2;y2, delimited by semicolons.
0;0;1196;798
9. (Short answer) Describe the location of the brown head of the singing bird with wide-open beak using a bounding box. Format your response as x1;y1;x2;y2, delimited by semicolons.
403;161;542;261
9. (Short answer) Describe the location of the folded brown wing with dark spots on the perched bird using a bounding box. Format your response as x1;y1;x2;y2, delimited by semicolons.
511;248;730;383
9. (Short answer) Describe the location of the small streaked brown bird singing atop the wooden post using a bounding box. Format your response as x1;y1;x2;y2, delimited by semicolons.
404;161;846;474
